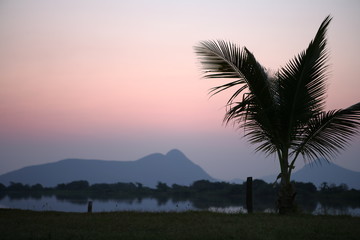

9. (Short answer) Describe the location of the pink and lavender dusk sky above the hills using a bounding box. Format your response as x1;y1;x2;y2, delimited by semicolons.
0;0;360;179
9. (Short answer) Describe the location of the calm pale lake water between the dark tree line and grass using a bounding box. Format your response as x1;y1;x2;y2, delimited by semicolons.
0;195;360;216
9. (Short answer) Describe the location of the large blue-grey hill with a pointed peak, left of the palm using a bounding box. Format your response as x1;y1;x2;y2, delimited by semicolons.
0;150;214;187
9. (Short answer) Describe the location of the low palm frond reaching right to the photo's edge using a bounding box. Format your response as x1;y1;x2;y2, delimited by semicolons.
293;102;360;161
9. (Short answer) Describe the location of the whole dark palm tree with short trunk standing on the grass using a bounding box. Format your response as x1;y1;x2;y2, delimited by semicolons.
195;16;360;214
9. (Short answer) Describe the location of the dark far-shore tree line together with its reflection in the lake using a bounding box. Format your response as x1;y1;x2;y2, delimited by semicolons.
0;179;360;212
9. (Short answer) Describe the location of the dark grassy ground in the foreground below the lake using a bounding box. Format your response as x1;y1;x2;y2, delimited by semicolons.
0;209;360;240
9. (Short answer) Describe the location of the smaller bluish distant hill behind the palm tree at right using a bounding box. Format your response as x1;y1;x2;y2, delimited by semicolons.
263;163;360;189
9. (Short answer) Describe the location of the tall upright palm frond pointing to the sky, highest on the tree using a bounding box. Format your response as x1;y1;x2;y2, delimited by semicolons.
279;16;331;146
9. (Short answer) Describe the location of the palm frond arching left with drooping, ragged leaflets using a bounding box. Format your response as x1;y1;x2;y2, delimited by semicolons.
195;40;278;152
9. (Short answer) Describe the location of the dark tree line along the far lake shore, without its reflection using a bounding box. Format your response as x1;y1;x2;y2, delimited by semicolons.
0;179;360;200
